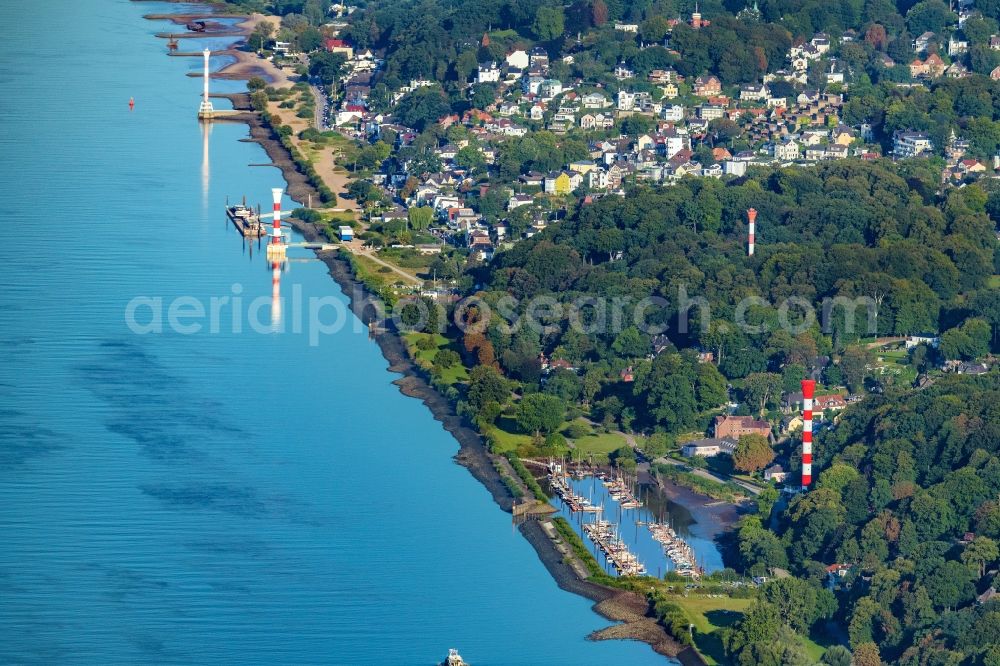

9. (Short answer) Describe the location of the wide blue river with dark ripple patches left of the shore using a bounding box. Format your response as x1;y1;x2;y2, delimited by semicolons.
0;0;666;666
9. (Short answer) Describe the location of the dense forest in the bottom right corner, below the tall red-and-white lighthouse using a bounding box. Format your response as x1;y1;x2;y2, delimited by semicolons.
727;373;1000;666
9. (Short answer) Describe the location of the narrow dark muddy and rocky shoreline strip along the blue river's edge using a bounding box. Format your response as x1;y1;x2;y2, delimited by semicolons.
143;7;720;666
